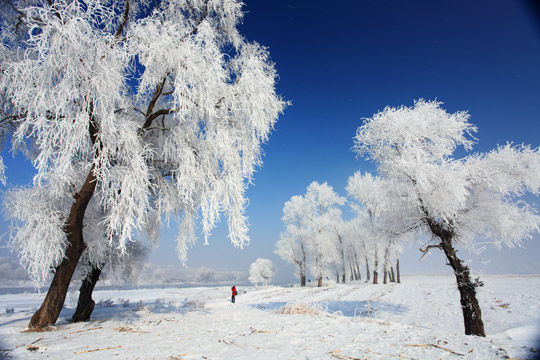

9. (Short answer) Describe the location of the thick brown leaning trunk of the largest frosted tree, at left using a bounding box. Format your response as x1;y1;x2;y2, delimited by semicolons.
28;166;96;329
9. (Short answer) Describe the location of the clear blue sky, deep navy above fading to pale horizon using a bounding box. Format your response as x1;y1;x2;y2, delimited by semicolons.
0;0;540;282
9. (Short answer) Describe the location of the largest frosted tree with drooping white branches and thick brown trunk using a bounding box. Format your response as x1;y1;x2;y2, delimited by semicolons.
0;0;286;328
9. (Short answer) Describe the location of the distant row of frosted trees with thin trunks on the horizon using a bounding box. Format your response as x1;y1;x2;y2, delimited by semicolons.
275;181;401;286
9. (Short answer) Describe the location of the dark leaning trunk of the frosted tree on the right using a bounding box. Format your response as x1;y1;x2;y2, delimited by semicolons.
440;237;486;336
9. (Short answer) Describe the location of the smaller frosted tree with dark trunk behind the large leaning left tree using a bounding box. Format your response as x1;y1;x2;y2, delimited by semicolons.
4;181;148;322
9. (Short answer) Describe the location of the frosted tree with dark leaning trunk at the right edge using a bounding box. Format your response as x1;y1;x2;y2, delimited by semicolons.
355;100;540;336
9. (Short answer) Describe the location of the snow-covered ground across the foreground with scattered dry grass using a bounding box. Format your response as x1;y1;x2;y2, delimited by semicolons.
0;276;540;360
